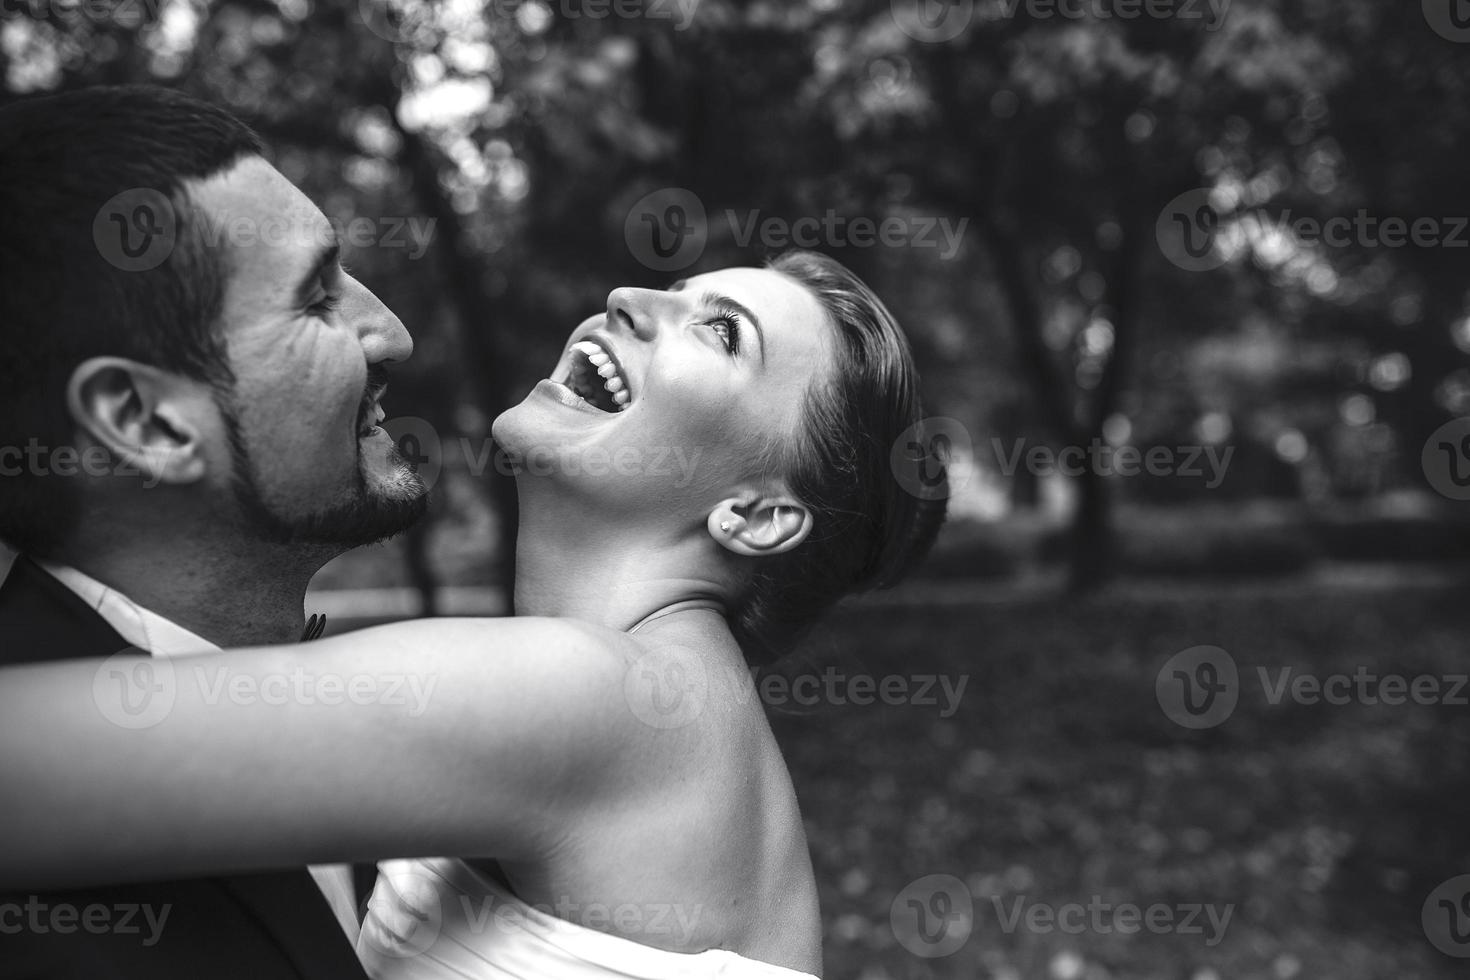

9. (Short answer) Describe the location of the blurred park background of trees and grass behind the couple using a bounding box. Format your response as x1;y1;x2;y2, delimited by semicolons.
0;0;1470;980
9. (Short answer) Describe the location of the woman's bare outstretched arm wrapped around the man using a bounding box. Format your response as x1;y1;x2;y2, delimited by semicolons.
0;619;678;889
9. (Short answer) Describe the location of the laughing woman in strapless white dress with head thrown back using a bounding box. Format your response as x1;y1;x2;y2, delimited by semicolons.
0;253;942;980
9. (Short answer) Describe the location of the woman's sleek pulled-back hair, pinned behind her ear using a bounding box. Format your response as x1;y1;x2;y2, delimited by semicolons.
731;251;945;664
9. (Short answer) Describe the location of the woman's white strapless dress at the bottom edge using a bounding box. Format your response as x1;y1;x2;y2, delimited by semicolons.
357;858;816;980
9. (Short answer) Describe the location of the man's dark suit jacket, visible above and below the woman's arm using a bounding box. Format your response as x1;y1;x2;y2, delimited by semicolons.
0;557;365;980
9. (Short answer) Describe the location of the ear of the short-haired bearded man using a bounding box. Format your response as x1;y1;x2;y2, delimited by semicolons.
66;357;207;486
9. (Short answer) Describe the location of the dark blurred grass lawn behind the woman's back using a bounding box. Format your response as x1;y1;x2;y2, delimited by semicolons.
773;588;1470;980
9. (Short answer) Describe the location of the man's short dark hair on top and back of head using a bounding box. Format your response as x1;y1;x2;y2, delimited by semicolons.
0;85;263;557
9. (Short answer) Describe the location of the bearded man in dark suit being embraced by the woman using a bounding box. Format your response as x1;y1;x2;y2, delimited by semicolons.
0;87;426;980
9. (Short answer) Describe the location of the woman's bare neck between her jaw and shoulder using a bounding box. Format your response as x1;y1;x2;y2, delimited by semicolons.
515;495;729;630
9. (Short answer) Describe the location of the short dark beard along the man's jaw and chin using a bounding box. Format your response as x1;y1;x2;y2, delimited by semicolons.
216;376;429;548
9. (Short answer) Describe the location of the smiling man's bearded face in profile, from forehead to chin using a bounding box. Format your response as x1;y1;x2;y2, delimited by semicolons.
191;157;428;547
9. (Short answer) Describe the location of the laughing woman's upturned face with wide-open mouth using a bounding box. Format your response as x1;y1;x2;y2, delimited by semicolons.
494;269;833;519
